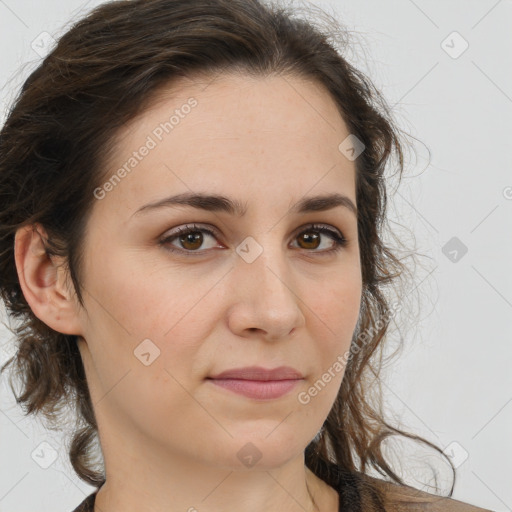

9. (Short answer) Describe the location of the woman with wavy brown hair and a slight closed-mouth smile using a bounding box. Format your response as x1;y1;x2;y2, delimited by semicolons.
0;0;496;512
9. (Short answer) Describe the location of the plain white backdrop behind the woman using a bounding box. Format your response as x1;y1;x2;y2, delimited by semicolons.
0;0;512;512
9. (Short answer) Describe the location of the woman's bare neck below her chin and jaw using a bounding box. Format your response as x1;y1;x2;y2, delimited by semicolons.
95;457;338;512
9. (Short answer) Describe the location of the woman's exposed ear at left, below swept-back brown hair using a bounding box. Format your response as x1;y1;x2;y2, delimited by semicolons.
14;224;82;335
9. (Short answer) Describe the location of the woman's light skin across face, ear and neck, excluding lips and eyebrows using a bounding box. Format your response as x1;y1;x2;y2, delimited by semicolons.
15;75;362;512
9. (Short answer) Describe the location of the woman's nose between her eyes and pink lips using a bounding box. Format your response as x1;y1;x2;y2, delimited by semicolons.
228;242;305;341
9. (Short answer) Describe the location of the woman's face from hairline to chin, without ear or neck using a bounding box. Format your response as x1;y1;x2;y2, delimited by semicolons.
79;75;361;468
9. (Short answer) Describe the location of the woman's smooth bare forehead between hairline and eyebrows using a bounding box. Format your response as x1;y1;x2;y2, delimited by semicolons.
93;75;355;216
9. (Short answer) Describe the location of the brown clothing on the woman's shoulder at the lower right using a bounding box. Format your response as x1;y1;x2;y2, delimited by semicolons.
360;473;492;512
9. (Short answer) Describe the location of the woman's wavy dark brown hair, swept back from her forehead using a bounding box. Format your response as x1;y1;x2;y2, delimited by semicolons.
0;0;455;504
